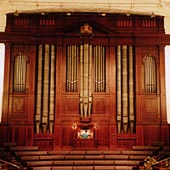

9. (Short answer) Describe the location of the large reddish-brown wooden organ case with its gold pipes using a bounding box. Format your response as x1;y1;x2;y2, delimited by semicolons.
0;13;169;150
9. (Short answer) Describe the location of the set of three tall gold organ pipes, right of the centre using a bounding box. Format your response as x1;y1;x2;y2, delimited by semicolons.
116;45;135;133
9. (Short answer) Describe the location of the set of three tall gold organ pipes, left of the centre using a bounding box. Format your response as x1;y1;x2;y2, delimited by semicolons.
35;44;56;133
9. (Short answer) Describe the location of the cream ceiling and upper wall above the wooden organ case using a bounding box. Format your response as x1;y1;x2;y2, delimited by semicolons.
0;0;170;34
